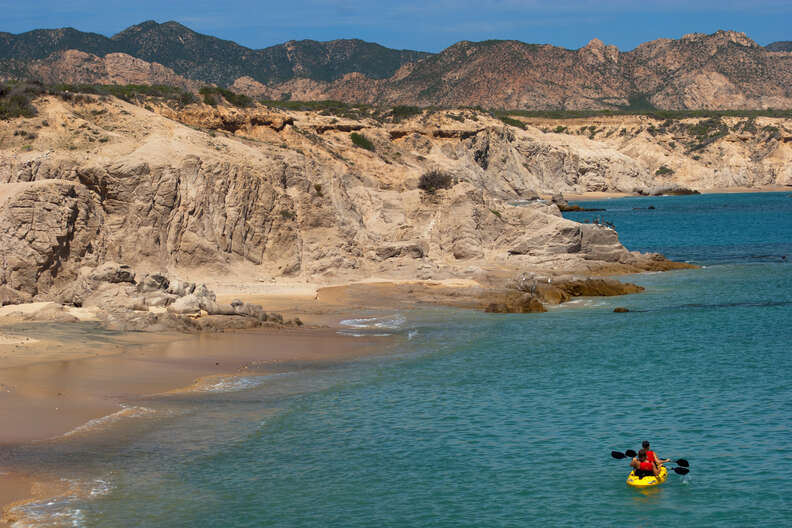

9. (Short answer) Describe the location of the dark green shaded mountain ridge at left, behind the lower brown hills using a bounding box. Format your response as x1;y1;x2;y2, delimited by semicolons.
0;21;429;85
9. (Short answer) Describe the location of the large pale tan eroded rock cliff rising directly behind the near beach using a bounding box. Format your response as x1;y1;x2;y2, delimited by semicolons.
0;96;688;298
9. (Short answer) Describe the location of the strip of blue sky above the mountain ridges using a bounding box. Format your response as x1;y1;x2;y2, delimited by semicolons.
0;0;792;51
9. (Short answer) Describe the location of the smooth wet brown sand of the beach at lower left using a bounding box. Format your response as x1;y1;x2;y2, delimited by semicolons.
0;318;391;526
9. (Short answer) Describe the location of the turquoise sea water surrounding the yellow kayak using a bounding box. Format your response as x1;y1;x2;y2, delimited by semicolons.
7;193;792;527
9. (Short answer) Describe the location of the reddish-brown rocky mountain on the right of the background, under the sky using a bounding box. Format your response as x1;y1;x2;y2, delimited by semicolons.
262;31;792;110
